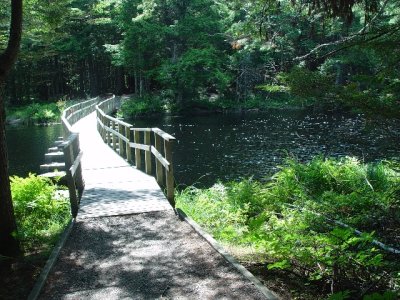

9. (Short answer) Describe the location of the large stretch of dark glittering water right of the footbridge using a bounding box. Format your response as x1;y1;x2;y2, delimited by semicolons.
131;111;400;186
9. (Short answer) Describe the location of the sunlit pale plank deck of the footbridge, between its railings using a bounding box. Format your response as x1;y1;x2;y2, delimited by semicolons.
73;113;172;219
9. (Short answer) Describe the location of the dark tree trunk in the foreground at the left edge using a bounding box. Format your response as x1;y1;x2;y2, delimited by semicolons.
0;0;22;256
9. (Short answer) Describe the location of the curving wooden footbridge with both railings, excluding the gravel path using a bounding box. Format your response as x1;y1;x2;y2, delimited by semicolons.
56;96;175;218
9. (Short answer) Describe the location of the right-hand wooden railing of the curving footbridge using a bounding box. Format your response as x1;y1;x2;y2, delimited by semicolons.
96;98;175;206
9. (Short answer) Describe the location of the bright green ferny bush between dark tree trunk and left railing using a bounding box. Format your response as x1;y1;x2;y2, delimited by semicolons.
11;174;71;252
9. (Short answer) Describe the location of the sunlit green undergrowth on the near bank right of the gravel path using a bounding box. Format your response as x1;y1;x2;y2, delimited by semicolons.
177;157;400;299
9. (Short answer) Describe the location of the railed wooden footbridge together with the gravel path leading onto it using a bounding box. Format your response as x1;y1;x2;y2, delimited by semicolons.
34;96;277;300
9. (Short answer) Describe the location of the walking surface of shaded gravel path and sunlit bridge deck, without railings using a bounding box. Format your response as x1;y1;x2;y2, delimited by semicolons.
39;115;265;300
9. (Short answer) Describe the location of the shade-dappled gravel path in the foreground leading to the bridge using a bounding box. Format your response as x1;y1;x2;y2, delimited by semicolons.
39;211;265;300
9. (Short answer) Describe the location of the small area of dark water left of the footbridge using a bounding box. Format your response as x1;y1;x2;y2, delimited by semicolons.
6;125;62;176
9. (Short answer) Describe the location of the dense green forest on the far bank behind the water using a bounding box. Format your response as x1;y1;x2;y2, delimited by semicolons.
0;0;400;115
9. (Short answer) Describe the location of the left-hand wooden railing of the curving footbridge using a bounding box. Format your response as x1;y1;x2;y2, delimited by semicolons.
61;98;102;218
